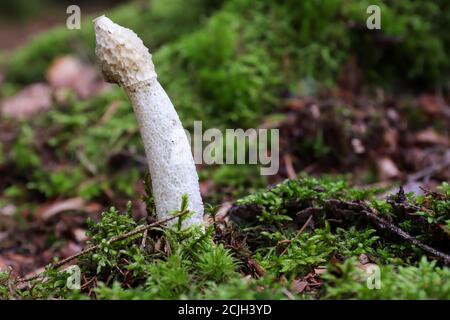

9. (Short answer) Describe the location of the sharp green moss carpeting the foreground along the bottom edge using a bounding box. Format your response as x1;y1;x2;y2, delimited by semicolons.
0;177;450;299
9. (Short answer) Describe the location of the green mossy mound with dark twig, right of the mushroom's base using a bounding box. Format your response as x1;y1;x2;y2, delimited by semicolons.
232;178;449;278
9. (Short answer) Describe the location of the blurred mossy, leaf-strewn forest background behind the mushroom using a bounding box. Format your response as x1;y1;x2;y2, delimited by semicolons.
0;0;450;274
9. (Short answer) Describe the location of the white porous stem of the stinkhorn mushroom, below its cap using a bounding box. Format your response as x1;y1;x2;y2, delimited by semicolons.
127;80;203;224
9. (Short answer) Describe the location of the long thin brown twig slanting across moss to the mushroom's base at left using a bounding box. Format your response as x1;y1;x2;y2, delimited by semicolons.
17;210;189;282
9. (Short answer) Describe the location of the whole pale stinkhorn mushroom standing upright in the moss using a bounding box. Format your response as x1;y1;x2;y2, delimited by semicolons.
94;16;203;225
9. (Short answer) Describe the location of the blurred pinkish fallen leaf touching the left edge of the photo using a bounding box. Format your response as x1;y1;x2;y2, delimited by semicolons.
0;83;52;119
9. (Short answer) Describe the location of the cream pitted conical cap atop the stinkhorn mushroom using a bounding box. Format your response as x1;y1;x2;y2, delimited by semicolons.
93;15;157;87
